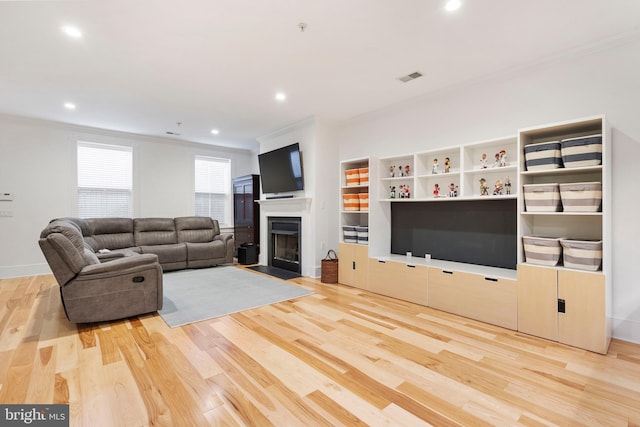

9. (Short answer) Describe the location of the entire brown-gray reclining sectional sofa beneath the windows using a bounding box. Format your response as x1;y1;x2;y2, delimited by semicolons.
38;217;234;323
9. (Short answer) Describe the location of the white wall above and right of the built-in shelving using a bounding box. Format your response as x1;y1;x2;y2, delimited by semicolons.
338;40;640;342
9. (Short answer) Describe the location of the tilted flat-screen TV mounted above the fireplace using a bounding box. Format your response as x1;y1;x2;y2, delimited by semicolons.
258;142;304;194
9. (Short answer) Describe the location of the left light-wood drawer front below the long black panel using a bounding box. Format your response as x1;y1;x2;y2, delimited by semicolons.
368;258;428;305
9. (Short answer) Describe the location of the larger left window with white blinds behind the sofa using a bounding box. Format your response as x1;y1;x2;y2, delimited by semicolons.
78;142;133;218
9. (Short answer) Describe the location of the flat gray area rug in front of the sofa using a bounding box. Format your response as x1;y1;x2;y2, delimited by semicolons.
158;266;313;328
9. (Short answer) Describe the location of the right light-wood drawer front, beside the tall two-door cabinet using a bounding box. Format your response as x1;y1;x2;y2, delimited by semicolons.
428;267;518;329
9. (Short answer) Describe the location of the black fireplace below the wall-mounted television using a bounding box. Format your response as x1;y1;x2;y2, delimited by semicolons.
267;217;302;273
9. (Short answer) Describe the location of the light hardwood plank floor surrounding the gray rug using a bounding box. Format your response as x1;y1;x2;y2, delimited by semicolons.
0;275;640;427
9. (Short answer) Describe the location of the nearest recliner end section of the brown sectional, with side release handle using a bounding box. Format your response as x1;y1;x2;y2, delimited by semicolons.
38;219;162;323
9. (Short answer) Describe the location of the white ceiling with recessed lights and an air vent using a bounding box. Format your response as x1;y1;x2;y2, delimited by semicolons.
0;0;640;149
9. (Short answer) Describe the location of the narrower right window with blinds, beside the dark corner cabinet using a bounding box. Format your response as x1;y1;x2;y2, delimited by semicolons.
195;156;232;227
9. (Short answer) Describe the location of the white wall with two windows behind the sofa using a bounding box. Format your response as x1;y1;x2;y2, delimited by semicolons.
0;115;257;278
